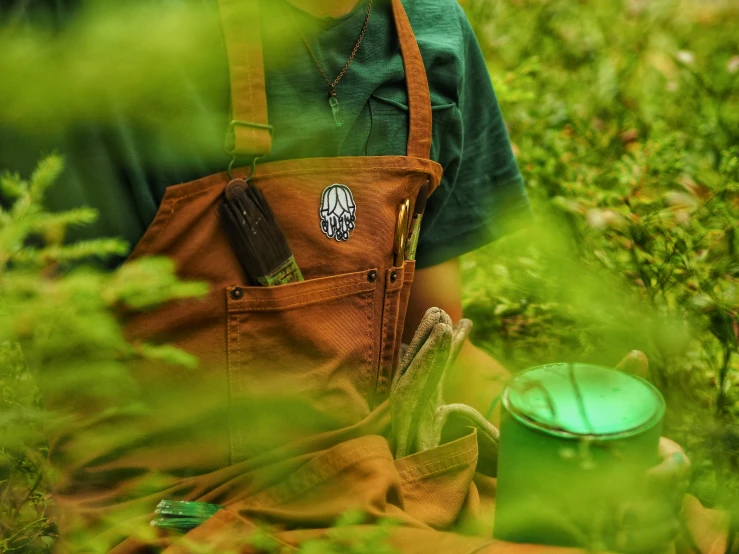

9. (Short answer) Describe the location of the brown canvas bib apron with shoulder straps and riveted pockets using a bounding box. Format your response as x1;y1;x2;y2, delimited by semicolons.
52;0;732;554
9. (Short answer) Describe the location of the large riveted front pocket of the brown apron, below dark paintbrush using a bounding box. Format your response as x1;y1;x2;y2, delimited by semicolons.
225;269;380;463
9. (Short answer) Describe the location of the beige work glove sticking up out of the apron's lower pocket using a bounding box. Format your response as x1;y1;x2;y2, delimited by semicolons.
390;308;498;460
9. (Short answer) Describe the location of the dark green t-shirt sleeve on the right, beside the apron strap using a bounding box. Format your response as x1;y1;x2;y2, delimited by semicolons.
416;2;531;268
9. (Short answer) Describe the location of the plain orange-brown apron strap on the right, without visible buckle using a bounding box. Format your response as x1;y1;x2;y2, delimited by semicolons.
392;0;432;159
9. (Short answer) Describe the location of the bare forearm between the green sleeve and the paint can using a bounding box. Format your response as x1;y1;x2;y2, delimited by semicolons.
403;258;509;414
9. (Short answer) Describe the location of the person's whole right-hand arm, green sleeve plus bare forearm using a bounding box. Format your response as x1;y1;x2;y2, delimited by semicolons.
404;3;531;415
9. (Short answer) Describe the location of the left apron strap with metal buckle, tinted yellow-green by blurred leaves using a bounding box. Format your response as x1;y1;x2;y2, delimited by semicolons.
218;0;272;159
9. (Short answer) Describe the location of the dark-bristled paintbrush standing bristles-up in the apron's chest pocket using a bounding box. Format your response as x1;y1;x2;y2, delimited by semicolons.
219;179;303;287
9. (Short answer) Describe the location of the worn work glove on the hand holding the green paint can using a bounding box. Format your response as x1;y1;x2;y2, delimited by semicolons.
616;350;690;553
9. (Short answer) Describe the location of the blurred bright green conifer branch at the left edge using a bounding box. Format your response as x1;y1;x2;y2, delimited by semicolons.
0;156;206;552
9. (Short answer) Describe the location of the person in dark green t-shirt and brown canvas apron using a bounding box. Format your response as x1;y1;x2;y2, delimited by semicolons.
0;0;728;553
